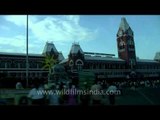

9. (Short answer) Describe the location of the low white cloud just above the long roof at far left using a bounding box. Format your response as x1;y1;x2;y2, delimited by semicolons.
0;35;45;54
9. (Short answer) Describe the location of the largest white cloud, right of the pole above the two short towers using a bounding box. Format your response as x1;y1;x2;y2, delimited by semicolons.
30;16;97;41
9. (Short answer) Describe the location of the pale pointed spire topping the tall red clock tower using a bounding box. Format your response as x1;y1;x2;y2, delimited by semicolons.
117;17;133;37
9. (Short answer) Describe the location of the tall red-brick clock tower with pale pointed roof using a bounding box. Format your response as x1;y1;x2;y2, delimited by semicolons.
117;17;136;69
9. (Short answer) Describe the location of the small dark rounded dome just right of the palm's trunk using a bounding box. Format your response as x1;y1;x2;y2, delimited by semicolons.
51;64;65;74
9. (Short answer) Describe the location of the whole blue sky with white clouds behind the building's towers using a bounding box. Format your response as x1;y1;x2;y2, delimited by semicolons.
0;15;160;59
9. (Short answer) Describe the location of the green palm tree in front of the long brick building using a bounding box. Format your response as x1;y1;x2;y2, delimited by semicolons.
43;55;57;80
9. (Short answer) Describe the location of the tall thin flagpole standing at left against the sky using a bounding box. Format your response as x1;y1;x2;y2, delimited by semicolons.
26;15;28;87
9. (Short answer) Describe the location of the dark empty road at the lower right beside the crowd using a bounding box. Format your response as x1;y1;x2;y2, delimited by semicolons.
103;88;160;105
